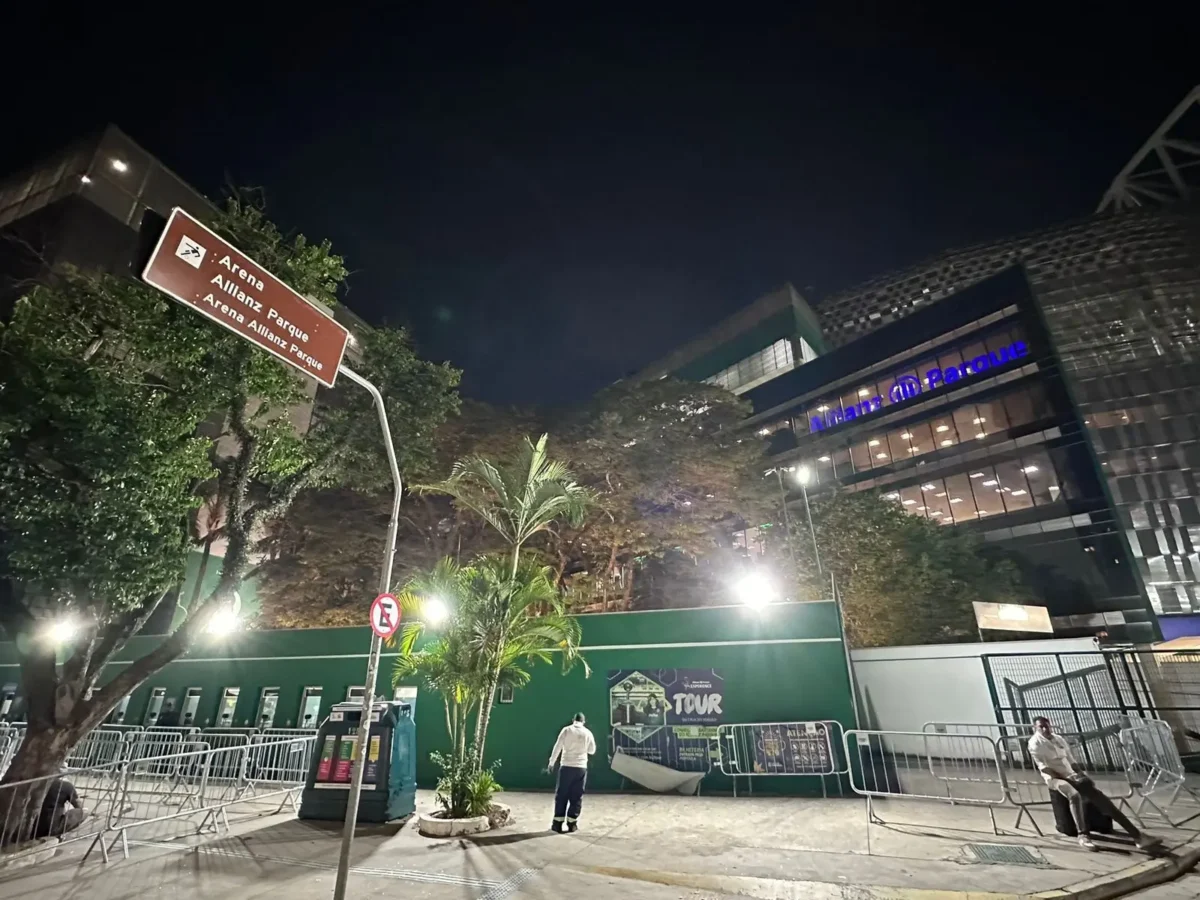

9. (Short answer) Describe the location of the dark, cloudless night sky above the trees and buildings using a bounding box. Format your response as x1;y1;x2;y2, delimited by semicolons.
0;8;1200;403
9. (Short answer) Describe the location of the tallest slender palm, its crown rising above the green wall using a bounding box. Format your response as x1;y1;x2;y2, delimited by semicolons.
414;434;594;764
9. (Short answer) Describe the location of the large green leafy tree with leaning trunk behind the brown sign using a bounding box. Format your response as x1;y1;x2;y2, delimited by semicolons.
0;198;458;781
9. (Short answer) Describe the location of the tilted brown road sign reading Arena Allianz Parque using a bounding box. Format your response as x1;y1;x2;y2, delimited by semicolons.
142;206;349;388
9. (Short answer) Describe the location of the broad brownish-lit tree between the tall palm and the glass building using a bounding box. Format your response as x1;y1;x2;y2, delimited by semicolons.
545;378;778;608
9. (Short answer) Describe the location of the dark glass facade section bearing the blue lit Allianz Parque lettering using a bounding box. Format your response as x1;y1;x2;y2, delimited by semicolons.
745;268;1156;640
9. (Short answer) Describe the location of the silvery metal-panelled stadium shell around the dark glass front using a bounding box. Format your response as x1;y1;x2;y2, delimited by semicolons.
817;206;1200;616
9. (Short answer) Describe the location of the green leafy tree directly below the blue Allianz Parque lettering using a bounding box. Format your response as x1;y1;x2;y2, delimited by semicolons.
792;491;1037;647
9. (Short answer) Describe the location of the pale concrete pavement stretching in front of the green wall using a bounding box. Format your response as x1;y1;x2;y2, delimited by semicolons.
0;792;1200;900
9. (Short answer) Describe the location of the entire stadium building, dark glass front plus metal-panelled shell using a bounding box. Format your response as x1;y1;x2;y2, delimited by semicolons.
641;204;1200;641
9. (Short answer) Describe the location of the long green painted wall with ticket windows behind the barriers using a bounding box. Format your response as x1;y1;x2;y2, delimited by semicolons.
0;602;853;792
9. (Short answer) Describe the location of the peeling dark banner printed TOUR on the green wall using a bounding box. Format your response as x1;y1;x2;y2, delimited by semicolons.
608;668;725;772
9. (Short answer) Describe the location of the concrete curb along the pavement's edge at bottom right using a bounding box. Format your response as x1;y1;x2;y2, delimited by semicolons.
564;838;1200;900
